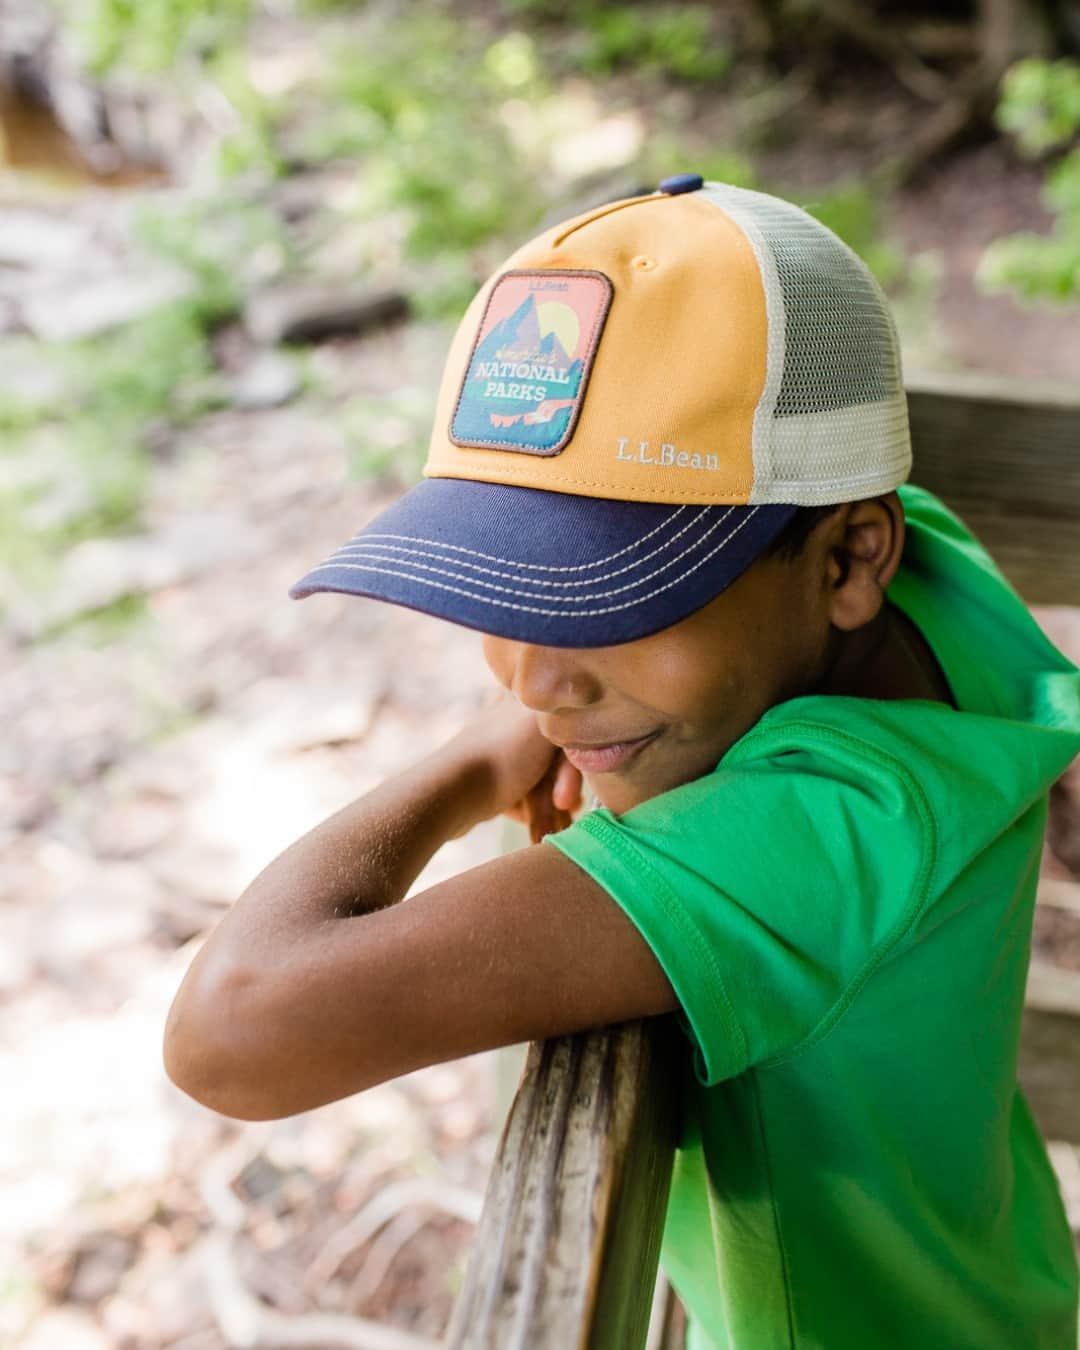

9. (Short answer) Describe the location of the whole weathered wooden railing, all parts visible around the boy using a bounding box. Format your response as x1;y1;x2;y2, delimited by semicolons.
448;375;1080;1350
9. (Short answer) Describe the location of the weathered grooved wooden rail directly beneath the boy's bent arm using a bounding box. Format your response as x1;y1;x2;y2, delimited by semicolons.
447;1018;678;1350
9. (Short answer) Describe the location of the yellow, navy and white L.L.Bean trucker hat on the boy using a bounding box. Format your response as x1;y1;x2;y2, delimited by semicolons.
289;174;911;647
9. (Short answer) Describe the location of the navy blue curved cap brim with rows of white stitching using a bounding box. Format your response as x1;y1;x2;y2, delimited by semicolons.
289;478;798;647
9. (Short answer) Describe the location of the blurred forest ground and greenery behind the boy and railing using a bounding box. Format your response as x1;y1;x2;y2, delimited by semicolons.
0;0;1080;1350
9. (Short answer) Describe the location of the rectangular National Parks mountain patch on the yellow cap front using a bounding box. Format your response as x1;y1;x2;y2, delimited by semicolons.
450;270;612;455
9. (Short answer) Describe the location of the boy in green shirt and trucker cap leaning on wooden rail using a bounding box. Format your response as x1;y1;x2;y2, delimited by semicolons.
166;174;1080;1350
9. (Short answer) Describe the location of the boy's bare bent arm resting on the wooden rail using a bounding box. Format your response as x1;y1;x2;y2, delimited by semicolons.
165;709;676;1119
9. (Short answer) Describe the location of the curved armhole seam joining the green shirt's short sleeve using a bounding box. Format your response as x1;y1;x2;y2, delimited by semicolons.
738;720;937;1069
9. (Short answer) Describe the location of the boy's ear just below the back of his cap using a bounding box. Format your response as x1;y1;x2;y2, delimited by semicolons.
826;493;905;632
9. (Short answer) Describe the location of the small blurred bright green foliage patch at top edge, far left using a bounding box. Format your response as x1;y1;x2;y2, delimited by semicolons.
64;0;251;74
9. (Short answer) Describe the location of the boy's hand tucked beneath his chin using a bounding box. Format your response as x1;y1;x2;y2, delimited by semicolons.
448;698;582;844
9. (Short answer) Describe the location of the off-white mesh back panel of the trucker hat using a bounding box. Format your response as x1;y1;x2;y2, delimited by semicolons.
701;182;911;506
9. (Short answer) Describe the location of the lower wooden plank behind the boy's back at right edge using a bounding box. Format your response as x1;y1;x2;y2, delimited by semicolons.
1021;961;1080;1143
